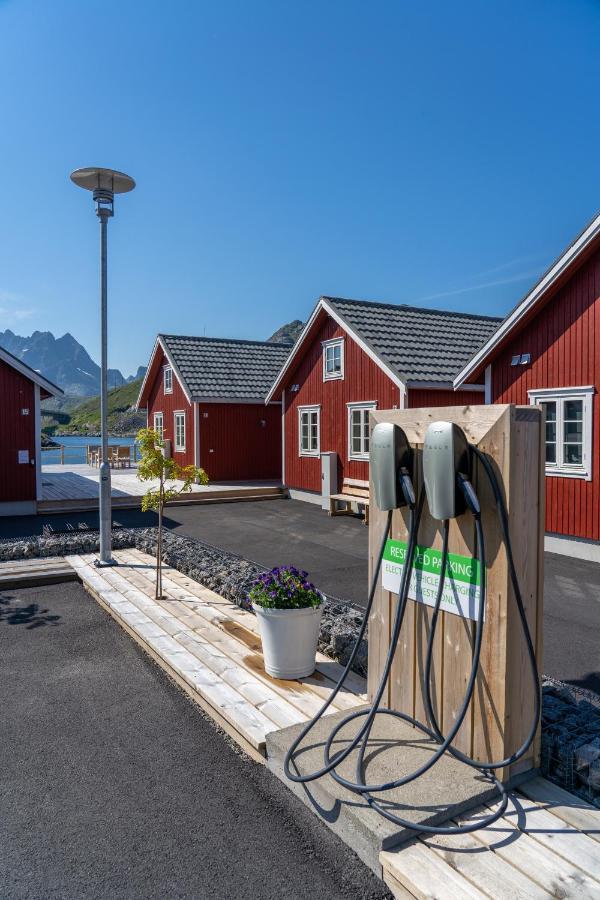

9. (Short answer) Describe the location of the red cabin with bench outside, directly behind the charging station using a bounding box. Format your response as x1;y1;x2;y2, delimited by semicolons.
267;297;500;503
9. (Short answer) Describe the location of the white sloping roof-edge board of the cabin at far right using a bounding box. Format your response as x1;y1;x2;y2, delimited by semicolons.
454;214;600;388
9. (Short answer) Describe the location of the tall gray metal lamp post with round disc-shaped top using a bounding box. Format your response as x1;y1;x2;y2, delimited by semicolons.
71;168;135;566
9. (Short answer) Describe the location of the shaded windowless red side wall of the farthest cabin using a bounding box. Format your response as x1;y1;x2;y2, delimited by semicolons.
199;403;281;481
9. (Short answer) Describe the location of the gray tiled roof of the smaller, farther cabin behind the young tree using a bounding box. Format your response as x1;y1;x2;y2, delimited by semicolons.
159;334;292;402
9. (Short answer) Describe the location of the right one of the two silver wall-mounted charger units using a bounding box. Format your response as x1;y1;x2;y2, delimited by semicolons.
423;422;471;520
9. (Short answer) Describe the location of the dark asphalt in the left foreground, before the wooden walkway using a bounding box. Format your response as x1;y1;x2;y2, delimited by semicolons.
0;584;390;900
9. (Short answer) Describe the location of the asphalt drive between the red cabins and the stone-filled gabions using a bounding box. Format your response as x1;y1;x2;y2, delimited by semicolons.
0;499;600;694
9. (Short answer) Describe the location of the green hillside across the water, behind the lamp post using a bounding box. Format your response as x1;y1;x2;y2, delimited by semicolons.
42;378;146;435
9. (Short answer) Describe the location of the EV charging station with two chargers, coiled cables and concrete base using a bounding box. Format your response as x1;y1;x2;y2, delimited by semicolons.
273;405;544;868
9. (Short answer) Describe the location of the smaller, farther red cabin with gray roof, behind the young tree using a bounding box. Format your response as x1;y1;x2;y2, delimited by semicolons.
137;334;290;481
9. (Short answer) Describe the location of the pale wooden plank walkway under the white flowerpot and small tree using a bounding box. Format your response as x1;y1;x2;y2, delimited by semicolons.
67;550;366;760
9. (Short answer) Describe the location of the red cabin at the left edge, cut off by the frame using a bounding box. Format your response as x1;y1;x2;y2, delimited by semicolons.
0;348;63;516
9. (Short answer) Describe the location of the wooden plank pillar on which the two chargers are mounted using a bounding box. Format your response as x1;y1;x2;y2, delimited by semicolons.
368;405;544;779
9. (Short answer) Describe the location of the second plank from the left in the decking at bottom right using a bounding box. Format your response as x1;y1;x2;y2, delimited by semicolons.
423;834;552;900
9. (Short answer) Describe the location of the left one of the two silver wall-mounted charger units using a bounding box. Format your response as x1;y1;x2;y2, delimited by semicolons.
369;422;412;510
